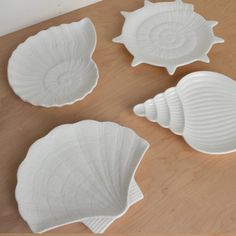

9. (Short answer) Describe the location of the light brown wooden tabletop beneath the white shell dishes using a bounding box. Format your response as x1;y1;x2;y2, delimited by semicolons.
0;0;236;234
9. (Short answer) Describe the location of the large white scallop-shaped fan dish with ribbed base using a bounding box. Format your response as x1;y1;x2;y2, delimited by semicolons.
15;120;149;233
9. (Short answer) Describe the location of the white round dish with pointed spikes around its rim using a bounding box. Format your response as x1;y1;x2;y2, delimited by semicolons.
113;0;224;75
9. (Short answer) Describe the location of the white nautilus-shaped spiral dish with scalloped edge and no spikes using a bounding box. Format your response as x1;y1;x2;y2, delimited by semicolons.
8;18;98;107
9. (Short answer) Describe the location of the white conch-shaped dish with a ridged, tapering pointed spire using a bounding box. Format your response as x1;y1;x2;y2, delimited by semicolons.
134;71;236;154
